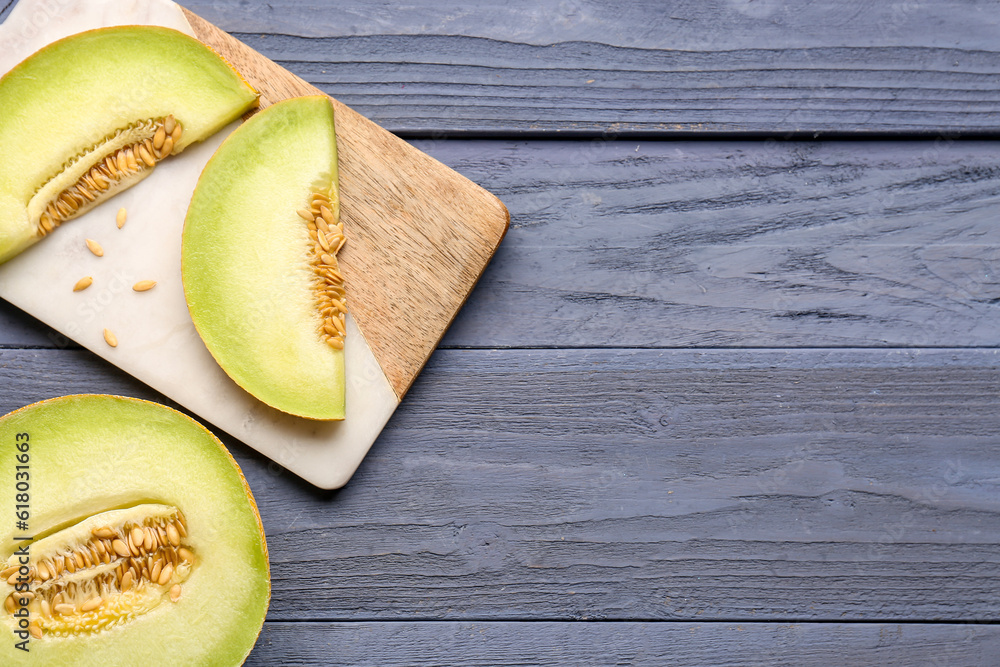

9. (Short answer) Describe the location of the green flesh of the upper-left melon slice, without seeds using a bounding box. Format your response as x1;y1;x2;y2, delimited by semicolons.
0;26;257;261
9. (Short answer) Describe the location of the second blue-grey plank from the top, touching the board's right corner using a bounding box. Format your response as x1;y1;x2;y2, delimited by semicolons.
0;140;1000;347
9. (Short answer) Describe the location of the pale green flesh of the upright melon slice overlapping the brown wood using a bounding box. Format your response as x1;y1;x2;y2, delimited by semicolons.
181;96;344;420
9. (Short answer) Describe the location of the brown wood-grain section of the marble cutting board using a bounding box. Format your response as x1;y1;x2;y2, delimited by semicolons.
185;11;509;399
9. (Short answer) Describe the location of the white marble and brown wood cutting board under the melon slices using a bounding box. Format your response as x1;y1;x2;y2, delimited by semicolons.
0;0;509;488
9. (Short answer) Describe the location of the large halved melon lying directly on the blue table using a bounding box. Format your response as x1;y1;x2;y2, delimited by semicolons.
0;395;270;666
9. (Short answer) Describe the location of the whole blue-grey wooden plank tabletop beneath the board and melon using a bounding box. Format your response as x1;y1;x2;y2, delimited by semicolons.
0;0;1000;665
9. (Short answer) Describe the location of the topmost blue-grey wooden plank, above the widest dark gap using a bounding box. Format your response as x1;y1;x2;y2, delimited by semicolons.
174;0;1000;135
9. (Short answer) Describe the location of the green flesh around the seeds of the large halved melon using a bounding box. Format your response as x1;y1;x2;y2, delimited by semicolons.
0;395;270;667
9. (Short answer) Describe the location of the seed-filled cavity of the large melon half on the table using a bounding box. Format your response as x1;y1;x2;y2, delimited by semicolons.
0;504;196;639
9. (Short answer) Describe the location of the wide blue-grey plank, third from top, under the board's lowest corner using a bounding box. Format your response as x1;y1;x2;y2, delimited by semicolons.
0;349;1000;621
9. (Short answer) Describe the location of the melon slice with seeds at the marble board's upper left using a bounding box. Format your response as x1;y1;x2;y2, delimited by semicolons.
0;26;257;261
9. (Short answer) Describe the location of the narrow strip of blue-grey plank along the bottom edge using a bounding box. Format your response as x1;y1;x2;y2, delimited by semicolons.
246;621;1000;667
